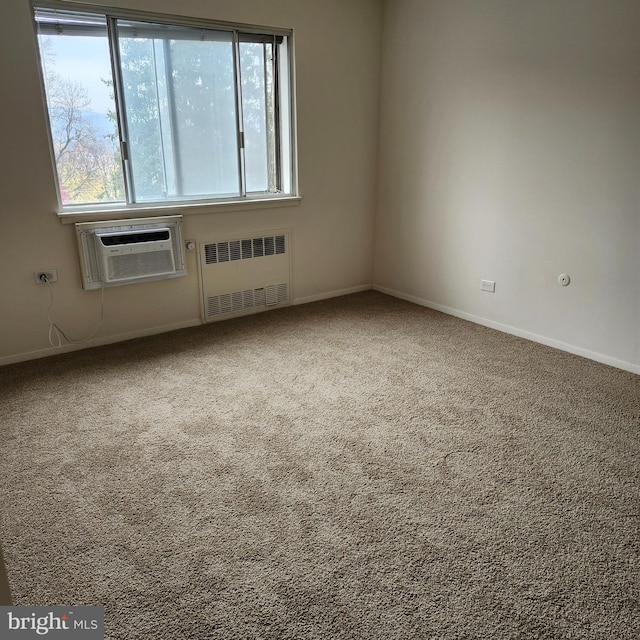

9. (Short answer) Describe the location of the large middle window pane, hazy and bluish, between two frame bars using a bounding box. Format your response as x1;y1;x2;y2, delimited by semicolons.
118;21;240;202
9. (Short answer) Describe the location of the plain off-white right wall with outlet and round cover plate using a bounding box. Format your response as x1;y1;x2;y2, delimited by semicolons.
374;0;640;373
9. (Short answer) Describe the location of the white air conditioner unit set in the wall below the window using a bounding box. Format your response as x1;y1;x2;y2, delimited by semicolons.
75;216;186;289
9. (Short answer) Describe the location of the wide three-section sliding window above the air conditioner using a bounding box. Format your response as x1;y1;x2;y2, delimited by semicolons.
34;0;295;211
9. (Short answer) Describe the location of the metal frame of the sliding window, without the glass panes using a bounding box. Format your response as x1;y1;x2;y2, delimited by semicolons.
31;0;301;222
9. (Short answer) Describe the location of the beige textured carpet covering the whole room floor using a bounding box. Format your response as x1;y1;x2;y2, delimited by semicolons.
0;292;640;640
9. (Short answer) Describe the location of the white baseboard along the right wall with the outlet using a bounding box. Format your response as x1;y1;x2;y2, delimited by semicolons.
373;284;640;374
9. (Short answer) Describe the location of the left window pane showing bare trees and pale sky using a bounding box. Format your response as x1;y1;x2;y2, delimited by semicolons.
38;12;125;205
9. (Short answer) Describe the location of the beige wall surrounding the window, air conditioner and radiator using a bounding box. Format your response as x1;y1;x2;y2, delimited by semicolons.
0;0;382;364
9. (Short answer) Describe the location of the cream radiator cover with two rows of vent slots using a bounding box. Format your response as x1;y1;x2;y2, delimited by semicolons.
198;230;291;322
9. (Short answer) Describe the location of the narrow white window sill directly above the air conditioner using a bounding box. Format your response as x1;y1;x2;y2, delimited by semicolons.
57;196;302;224
